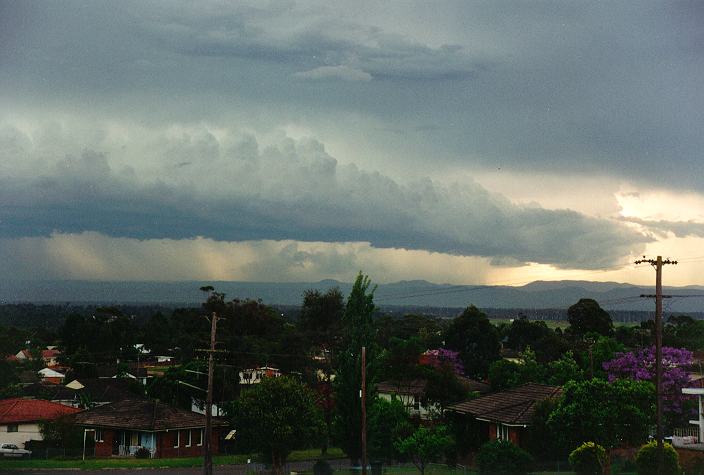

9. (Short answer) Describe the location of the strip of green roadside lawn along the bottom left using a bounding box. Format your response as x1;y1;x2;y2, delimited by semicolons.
0;448;344;470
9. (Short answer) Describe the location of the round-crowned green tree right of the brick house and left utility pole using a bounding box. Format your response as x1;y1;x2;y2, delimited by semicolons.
230;376;323;474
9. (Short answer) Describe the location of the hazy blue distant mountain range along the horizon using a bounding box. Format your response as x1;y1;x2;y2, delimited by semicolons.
0;280;704;312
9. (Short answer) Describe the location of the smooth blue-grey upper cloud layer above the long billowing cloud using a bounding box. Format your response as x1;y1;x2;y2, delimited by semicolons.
0;1;704;190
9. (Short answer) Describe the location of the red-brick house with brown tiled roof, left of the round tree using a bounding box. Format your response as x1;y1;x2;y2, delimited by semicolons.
74;400;227;458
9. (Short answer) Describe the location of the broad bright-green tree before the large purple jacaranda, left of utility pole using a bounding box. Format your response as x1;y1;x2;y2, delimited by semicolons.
548;379;655;455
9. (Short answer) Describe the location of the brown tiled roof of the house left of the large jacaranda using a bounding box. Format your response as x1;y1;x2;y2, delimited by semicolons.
448;383;562;425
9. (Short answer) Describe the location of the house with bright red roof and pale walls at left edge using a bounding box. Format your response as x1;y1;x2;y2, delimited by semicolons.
0;398;79;447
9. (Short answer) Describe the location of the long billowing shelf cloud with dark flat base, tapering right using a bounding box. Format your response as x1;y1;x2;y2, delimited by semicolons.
0;124;650;269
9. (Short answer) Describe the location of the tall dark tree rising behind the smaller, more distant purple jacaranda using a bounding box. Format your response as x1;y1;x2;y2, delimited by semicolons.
445;305;501;379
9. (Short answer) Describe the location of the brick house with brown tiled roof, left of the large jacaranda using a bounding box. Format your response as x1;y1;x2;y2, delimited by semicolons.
447;383;562;446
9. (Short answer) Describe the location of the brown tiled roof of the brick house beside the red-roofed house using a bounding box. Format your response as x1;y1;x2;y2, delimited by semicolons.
74;400;227;432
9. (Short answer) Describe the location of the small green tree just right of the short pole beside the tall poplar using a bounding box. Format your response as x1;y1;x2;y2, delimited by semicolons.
367;398;413;462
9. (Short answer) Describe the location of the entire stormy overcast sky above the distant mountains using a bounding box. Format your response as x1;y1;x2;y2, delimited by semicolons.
0;0;704;285
